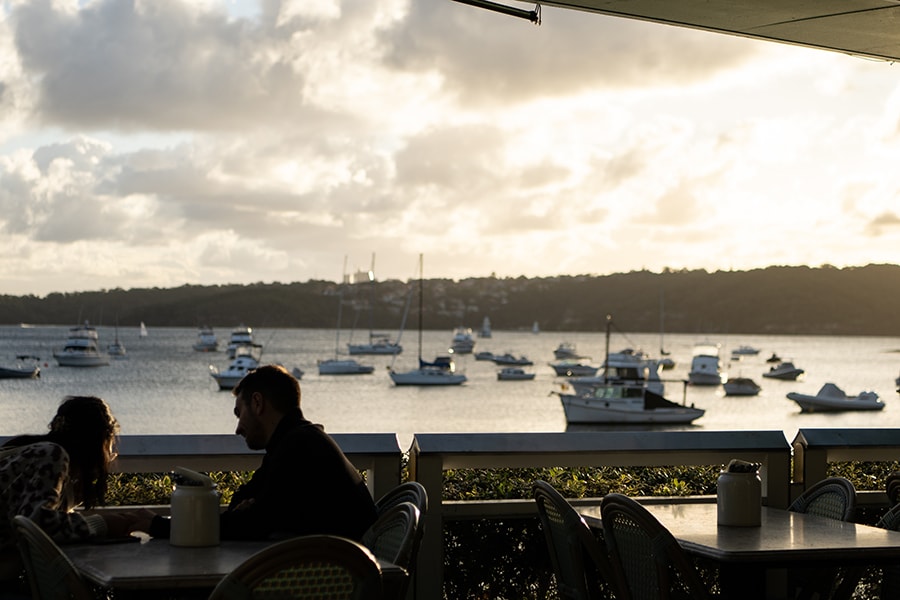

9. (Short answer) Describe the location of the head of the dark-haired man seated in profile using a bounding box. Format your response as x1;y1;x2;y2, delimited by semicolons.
233;365;300;450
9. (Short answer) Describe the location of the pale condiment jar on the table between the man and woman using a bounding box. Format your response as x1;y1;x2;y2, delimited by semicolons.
169;467;220;546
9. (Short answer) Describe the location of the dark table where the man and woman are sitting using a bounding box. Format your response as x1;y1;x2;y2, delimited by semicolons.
60;538;407;598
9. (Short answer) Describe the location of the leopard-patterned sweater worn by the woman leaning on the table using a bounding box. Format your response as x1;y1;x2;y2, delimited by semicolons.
0;442;106;551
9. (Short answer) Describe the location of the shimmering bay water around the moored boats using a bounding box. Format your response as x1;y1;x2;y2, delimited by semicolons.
0;324;900;447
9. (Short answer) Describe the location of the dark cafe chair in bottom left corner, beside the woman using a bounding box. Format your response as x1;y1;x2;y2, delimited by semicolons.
13;515;94;600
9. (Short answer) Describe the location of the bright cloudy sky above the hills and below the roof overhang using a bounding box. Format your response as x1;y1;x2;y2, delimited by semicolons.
0;0;900;296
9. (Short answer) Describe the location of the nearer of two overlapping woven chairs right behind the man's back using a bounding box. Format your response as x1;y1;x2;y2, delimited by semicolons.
362;502;422;599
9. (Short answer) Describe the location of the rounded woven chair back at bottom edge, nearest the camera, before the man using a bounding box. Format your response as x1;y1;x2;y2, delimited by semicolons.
209;535;382;600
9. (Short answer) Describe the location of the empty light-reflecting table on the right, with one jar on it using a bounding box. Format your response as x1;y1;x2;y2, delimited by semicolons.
576;503;900;598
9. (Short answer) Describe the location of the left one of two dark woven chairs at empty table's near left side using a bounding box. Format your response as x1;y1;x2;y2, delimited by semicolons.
533;480;624;600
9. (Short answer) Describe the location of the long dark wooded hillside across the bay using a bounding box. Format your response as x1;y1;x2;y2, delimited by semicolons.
0;265;900;336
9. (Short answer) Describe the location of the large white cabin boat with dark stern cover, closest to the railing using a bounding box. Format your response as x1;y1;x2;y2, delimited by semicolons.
558;383;706;424
